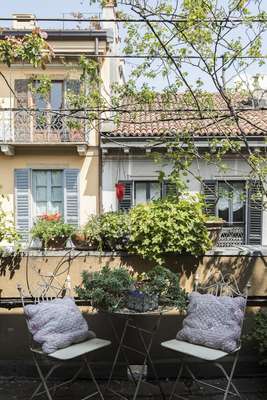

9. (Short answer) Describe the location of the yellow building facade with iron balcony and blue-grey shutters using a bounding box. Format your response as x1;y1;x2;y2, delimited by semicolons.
0;5;122;240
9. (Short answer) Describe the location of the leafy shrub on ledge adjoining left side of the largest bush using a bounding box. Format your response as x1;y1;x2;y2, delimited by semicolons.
99;212;130;250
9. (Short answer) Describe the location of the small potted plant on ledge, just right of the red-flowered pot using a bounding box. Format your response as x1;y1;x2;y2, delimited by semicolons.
71;215;101;251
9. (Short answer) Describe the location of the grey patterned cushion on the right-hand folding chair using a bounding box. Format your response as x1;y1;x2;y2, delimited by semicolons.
176;292;246;353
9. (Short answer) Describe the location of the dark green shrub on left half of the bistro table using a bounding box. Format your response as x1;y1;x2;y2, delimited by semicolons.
76;266;133;311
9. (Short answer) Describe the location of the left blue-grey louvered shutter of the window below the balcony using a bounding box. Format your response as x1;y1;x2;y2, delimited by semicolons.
15;169;30;242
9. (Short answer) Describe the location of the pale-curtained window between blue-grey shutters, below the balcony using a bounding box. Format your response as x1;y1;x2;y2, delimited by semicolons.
32;170;64;217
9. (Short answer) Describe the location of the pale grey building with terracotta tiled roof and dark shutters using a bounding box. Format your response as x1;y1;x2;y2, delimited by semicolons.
102;99;267;247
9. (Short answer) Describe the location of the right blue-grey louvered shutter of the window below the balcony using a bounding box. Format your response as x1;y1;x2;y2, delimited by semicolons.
64;169;80;226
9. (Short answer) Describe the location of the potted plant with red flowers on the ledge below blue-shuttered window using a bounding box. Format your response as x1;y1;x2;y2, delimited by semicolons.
31;213;74;250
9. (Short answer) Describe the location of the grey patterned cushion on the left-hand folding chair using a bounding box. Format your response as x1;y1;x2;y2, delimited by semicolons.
25;297;95;354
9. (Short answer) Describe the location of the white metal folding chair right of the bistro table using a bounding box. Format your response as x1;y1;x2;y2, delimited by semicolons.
161;275;250;400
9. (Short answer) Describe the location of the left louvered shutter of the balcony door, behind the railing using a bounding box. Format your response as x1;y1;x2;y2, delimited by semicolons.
14;79;31;143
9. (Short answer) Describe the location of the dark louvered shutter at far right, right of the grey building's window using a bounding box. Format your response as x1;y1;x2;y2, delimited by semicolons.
247;181;262;245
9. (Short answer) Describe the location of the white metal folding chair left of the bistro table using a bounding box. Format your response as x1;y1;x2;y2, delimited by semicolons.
18;273;111;400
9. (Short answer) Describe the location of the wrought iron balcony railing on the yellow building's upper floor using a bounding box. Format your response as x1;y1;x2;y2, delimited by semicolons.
0;109;89;144
